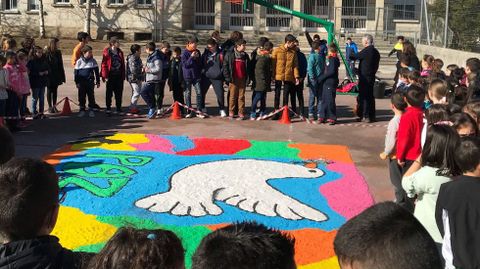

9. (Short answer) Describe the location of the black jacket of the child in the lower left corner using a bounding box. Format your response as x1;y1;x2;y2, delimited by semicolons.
0;236;93;269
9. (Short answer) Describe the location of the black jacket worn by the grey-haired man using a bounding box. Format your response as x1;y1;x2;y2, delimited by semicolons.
350;45;380;81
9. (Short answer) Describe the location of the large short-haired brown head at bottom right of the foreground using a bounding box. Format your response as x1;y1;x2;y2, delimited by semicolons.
333;202;441;269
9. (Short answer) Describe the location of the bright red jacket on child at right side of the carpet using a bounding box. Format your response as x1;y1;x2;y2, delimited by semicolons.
397;107;423;162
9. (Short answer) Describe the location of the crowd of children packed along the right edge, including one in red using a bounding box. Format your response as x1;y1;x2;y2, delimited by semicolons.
380;55;480;268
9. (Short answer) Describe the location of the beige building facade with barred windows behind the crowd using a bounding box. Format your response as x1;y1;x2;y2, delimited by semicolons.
0;0;419;39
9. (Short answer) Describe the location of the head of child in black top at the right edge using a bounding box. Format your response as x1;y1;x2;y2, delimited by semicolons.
455;137;480;177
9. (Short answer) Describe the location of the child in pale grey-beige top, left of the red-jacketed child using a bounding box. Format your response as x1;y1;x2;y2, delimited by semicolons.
380;92;413;210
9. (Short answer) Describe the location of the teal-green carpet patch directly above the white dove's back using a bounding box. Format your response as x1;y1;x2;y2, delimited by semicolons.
235;140;300;160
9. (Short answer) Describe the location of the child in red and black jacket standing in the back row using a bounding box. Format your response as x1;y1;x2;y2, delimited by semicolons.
101;37;125;113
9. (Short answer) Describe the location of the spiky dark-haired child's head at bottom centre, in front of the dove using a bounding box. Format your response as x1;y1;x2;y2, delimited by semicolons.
192;222;296;269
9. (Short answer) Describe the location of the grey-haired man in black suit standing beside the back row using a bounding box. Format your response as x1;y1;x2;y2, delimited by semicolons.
350;34;380;123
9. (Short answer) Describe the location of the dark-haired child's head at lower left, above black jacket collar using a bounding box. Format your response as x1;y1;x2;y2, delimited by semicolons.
0;158;60;242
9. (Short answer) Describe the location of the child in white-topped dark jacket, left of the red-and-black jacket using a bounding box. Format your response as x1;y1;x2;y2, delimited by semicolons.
74;45;100;118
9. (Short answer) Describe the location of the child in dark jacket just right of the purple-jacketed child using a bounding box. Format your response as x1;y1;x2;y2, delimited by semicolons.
202;39;227;118
